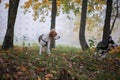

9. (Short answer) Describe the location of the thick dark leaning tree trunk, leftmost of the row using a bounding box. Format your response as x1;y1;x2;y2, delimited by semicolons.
2;0;19;50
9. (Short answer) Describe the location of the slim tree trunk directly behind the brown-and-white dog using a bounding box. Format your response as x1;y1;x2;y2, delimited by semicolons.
50;0;57;48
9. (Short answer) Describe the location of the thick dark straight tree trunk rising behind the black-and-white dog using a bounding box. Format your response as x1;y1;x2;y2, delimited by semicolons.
102;0;113;41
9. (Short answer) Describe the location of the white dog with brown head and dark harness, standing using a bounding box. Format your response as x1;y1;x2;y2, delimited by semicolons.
38;29;60;55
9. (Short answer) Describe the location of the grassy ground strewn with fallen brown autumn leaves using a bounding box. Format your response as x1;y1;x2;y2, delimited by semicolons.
0;46;120;80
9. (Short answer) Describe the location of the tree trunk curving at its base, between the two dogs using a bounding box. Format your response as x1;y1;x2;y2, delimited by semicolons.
79;0;89;50
